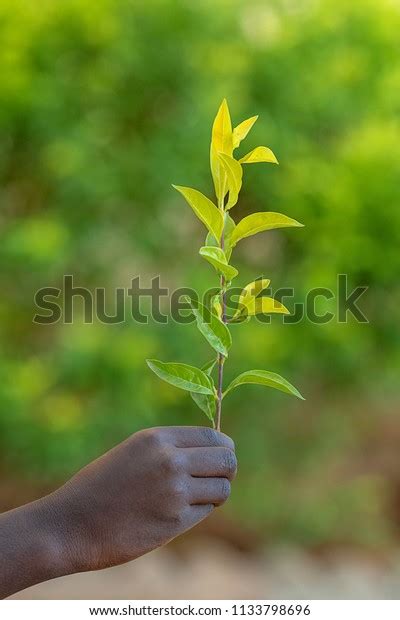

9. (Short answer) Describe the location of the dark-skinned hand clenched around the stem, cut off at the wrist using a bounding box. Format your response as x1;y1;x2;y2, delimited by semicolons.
46;427;236;572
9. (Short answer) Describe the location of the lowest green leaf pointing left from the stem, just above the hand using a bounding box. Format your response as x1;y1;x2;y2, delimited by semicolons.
146;360;214;394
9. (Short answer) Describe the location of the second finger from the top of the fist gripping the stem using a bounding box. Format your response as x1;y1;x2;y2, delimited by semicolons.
182;447;237;480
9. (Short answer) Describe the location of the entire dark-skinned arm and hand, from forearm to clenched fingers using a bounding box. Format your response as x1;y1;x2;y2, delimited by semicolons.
0;426;236;598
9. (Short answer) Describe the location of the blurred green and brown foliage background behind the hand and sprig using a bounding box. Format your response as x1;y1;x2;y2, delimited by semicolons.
0;0;400;598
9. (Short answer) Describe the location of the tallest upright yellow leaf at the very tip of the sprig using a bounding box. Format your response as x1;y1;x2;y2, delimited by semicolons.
210;99;233;202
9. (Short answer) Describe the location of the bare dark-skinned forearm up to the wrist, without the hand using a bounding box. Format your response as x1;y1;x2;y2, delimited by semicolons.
0;496;70;598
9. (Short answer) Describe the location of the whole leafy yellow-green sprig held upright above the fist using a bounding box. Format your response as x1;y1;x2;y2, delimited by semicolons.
147;99;303;430
